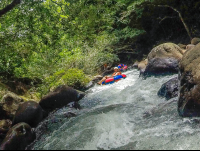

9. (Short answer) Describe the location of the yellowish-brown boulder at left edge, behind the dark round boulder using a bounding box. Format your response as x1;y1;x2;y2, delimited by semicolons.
0;93;24;120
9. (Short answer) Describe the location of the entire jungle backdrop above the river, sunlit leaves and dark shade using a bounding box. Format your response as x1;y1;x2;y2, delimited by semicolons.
0;0;200;98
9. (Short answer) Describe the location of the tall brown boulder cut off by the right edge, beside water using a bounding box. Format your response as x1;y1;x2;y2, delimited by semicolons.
178;43;200;117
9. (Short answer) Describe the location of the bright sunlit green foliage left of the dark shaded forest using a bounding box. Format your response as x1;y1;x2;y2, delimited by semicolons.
3;0;189;96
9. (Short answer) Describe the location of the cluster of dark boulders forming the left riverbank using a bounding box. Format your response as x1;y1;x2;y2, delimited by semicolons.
0;85;85;150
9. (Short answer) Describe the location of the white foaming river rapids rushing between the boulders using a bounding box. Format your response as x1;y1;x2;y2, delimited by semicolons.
33;70;200;150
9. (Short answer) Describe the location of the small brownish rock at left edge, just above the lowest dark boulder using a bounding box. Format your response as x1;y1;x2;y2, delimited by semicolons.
0;120;12;138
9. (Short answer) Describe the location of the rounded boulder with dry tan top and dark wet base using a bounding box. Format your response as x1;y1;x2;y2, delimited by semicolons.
144;43;185;76
